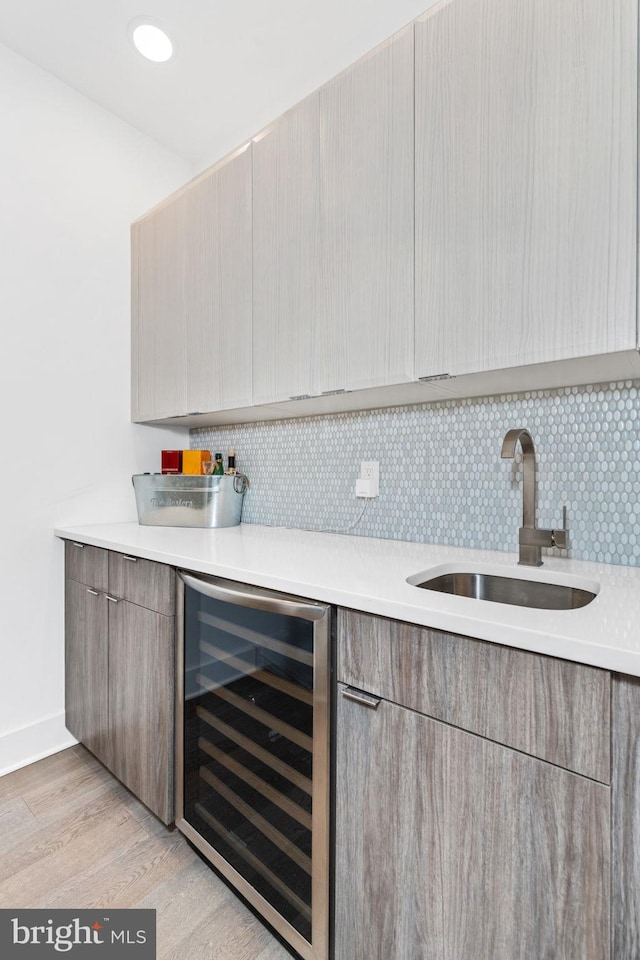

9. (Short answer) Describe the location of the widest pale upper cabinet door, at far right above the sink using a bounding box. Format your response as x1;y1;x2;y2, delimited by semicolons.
416;0;638;377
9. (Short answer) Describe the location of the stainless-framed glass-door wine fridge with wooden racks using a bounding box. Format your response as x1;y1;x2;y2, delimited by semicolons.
176;571;331;960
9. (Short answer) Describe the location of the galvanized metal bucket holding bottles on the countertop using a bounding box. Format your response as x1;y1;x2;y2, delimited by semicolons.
131;473;249;527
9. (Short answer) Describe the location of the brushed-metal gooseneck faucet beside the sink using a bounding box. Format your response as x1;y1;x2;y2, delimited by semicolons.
500;428;567;567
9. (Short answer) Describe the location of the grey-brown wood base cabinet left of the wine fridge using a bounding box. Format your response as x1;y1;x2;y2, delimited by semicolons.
65;543;174;823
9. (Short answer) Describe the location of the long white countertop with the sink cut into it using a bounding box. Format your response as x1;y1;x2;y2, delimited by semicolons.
55;522;640;676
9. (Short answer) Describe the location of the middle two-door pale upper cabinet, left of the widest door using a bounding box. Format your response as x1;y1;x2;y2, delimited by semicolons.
253;26;414;404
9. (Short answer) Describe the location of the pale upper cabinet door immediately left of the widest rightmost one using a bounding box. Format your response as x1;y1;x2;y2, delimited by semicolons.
314;26;414;392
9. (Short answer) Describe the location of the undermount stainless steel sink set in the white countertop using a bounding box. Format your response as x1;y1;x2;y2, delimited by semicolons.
407;565;599;610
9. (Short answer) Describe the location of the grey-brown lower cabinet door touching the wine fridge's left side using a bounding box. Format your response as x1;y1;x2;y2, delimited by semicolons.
109;600;174;823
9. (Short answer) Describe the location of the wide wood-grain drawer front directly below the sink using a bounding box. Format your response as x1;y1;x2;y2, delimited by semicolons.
338;610;611;783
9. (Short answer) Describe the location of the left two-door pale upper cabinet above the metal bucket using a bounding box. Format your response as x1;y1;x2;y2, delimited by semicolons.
132;147;252;420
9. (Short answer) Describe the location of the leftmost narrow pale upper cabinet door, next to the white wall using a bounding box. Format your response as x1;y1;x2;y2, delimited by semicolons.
131;191;188;421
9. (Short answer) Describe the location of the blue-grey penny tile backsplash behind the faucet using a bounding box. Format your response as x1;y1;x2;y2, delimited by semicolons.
190;380;640;566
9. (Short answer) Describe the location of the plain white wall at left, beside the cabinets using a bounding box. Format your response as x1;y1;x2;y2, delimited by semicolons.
0;45;192;774
